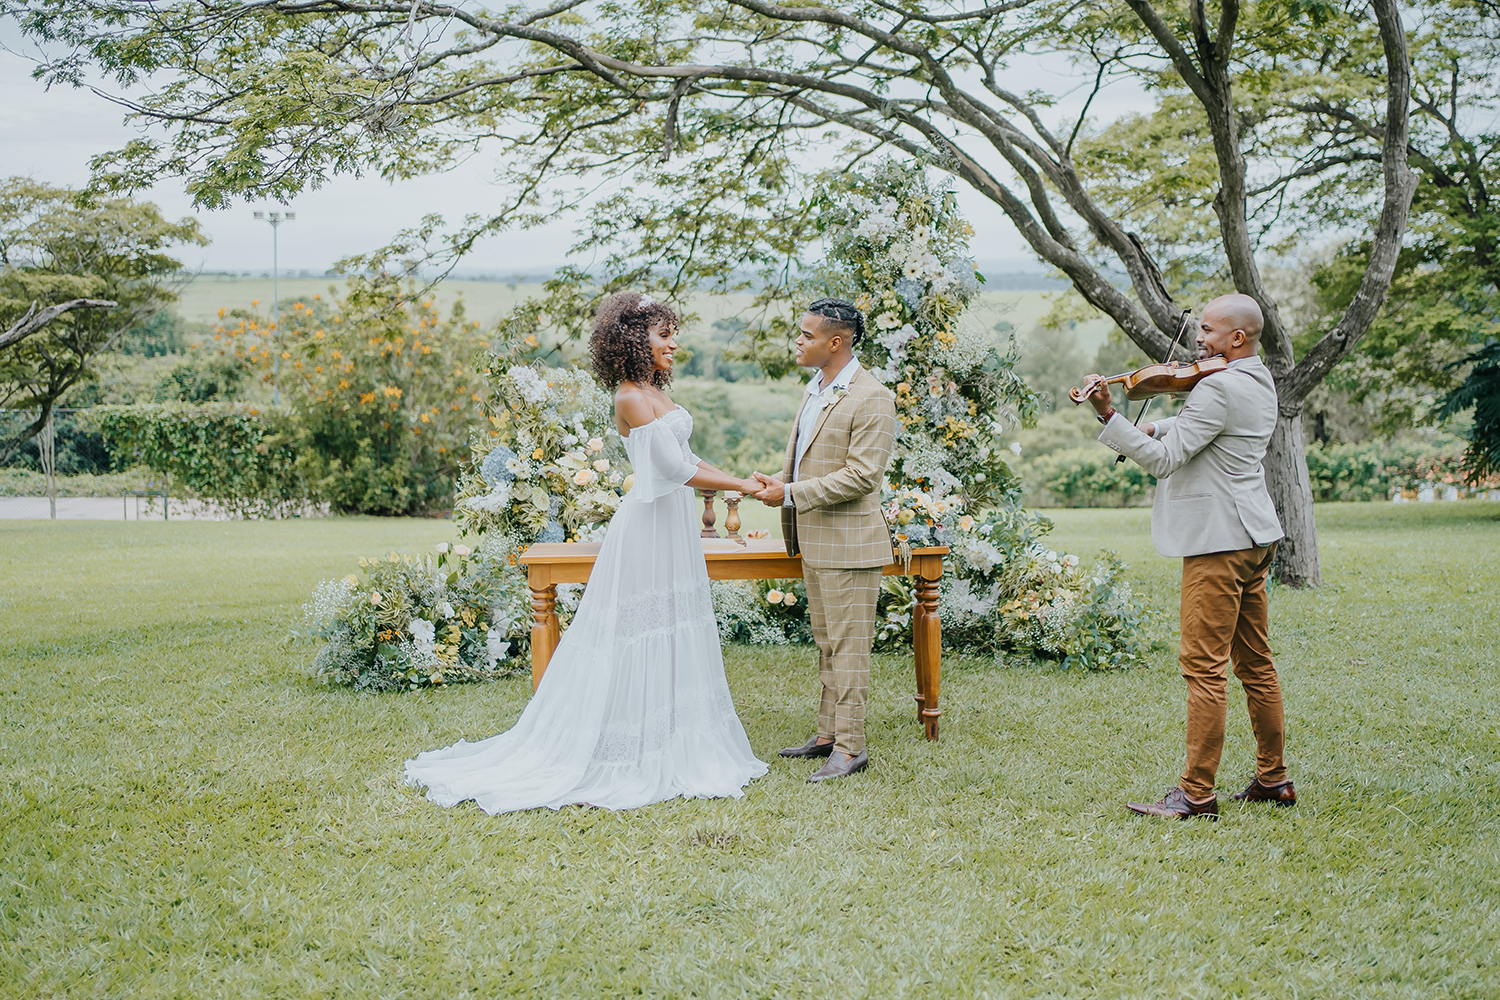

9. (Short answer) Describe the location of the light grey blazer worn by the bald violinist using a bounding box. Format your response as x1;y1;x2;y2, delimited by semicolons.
1100;357;1283;558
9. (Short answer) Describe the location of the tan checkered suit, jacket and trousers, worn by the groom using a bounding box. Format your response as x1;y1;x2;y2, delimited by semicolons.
777;369;896;756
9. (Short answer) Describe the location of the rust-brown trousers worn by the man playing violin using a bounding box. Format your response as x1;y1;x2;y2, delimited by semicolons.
1178;543;1287;801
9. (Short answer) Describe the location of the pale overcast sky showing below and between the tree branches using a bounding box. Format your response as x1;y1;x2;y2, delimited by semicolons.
0;25;1139;276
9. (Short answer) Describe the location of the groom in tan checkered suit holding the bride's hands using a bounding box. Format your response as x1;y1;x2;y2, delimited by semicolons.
756;298;896;781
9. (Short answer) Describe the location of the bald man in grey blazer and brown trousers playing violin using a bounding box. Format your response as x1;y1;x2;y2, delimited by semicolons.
1086;295;1298;819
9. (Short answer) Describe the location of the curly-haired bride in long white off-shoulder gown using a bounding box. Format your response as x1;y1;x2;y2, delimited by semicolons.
407;292;767;814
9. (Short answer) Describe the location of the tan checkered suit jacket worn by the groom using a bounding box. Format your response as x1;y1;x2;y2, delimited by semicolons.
777;367;896;570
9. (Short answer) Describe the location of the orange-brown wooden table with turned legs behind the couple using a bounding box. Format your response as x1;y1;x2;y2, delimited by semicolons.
521;538;948;739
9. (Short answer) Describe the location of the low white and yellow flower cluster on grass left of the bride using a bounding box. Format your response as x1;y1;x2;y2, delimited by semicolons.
302;543;525;691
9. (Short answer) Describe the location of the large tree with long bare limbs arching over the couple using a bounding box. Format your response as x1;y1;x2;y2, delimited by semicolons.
3;0;1415;583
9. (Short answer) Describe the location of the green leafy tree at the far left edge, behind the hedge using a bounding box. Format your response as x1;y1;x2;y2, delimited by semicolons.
0;177;207;462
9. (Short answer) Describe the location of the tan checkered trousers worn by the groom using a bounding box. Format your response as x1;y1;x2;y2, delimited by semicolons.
803;564;882;756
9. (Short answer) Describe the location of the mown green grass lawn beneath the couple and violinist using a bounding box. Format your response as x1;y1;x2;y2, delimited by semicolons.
0;502;1500;1000
